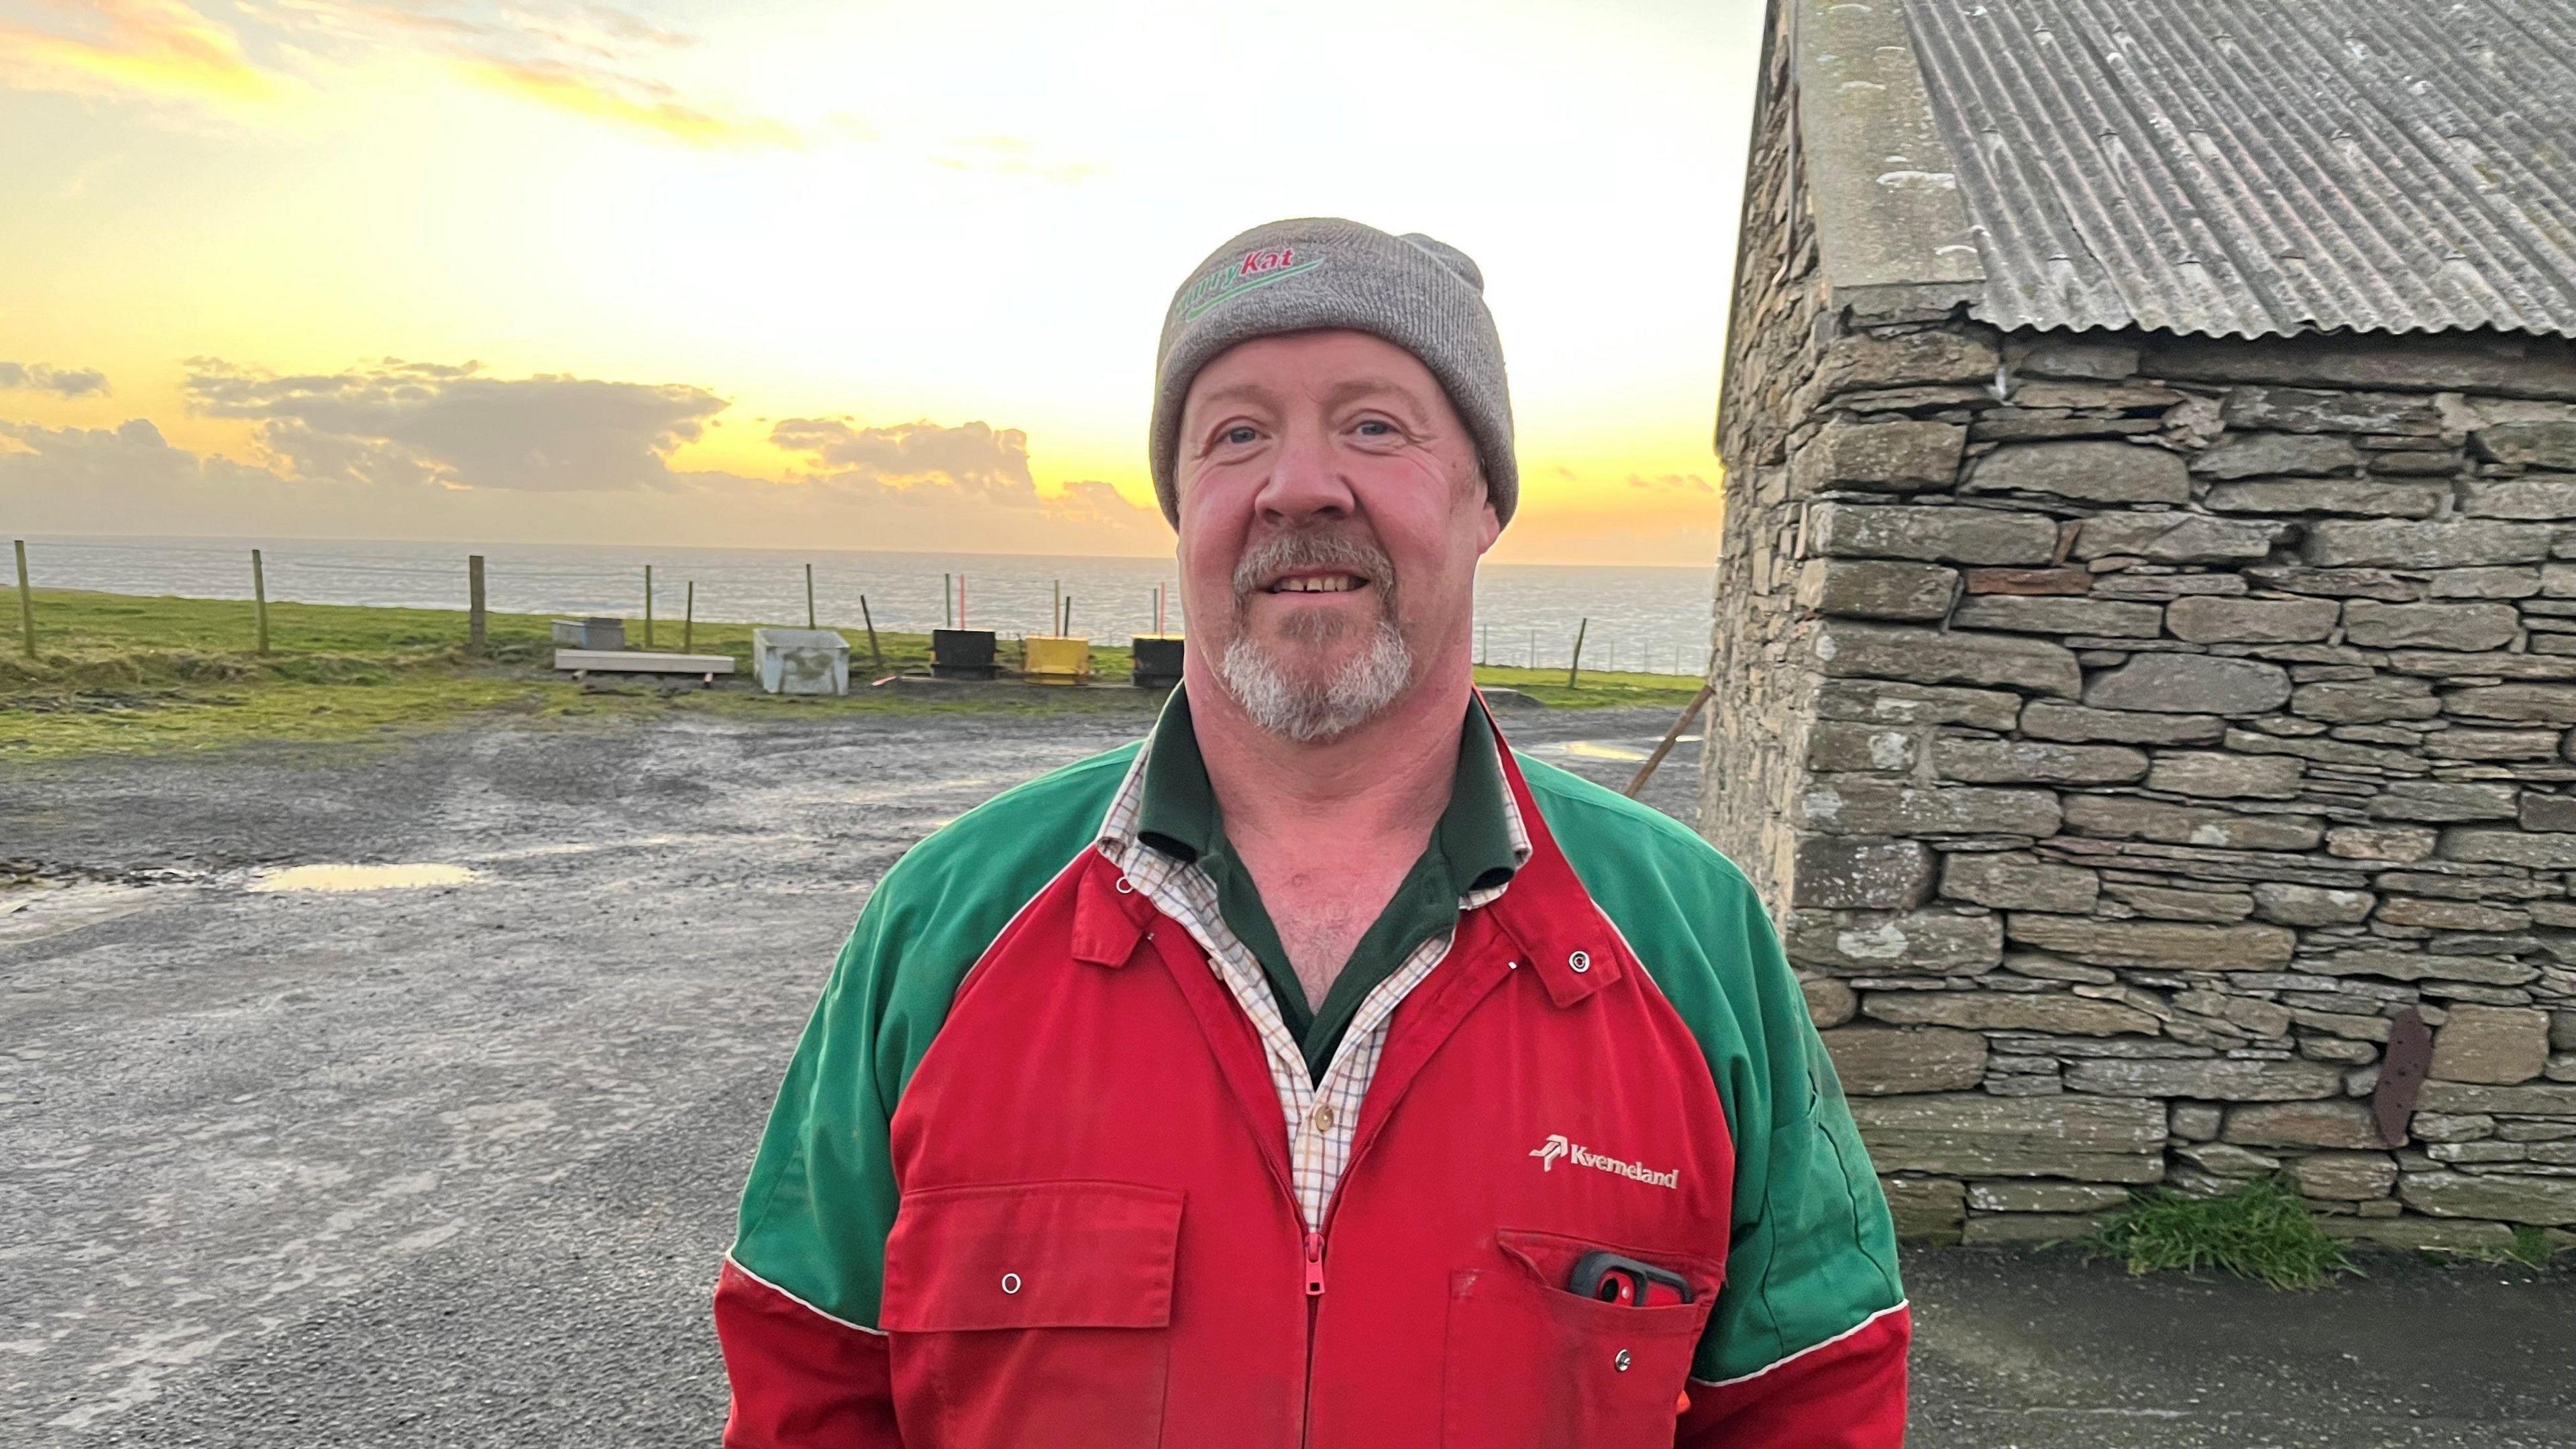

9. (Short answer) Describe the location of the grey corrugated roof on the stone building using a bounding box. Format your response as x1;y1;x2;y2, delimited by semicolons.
1904;0;2576;337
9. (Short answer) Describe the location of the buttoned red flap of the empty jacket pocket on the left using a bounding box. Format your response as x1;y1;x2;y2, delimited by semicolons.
883;1183;1180;1333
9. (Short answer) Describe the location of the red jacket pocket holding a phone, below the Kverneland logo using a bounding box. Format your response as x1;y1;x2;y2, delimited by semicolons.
1440;1227;1718;1449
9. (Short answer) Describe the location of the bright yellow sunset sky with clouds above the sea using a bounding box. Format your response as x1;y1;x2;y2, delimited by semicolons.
0;0;1760;565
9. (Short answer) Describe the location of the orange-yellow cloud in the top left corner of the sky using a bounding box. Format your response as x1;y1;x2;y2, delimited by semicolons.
0;0;281;103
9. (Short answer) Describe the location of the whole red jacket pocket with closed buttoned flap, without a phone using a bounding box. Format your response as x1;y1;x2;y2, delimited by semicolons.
883;1181;1180;1449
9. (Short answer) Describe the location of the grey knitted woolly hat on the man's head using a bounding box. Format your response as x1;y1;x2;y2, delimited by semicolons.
1151;217;1520;526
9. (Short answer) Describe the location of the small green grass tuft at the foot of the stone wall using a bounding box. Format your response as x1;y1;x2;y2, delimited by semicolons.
2092;1178;2359;1289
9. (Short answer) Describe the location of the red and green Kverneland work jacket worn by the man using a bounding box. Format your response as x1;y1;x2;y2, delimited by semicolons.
716;716;1909;1449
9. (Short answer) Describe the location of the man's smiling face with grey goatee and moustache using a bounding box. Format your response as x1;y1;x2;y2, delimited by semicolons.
1177;330;1502;740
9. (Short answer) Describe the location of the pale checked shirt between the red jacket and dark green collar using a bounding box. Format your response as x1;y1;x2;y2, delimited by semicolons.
1100;716;1530;1232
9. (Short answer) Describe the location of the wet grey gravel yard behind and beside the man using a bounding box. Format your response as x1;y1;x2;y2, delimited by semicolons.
0;696;2576;1449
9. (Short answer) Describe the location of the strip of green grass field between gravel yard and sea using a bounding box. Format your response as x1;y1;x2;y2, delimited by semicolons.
0;590;1698;761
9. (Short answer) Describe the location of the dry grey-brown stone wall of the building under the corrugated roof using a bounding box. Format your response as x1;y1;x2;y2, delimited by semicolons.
1703;182;2576;1248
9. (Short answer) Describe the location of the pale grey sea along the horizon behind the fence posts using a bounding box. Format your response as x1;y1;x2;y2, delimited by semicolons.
25;536;1715;676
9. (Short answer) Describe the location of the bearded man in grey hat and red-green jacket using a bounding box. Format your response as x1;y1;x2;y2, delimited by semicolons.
716;219;1909;1449
